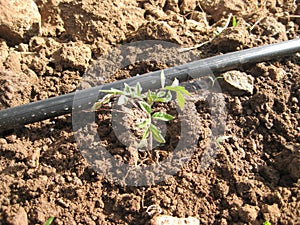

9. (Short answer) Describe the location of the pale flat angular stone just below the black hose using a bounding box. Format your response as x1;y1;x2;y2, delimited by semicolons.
220;70;254;95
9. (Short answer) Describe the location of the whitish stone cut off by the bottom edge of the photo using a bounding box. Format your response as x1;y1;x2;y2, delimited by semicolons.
150;215;200;225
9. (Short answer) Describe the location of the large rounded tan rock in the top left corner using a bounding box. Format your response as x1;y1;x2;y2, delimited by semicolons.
0;0;41;46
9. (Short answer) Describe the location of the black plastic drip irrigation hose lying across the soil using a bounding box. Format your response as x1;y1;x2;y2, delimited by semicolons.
0;38;300;132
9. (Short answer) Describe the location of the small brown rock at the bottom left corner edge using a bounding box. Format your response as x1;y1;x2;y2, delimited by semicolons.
6;205;28;225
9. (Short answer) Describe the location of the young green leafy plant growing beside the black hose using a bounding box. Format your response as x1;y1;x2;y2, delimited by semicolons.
92;71;190;150
